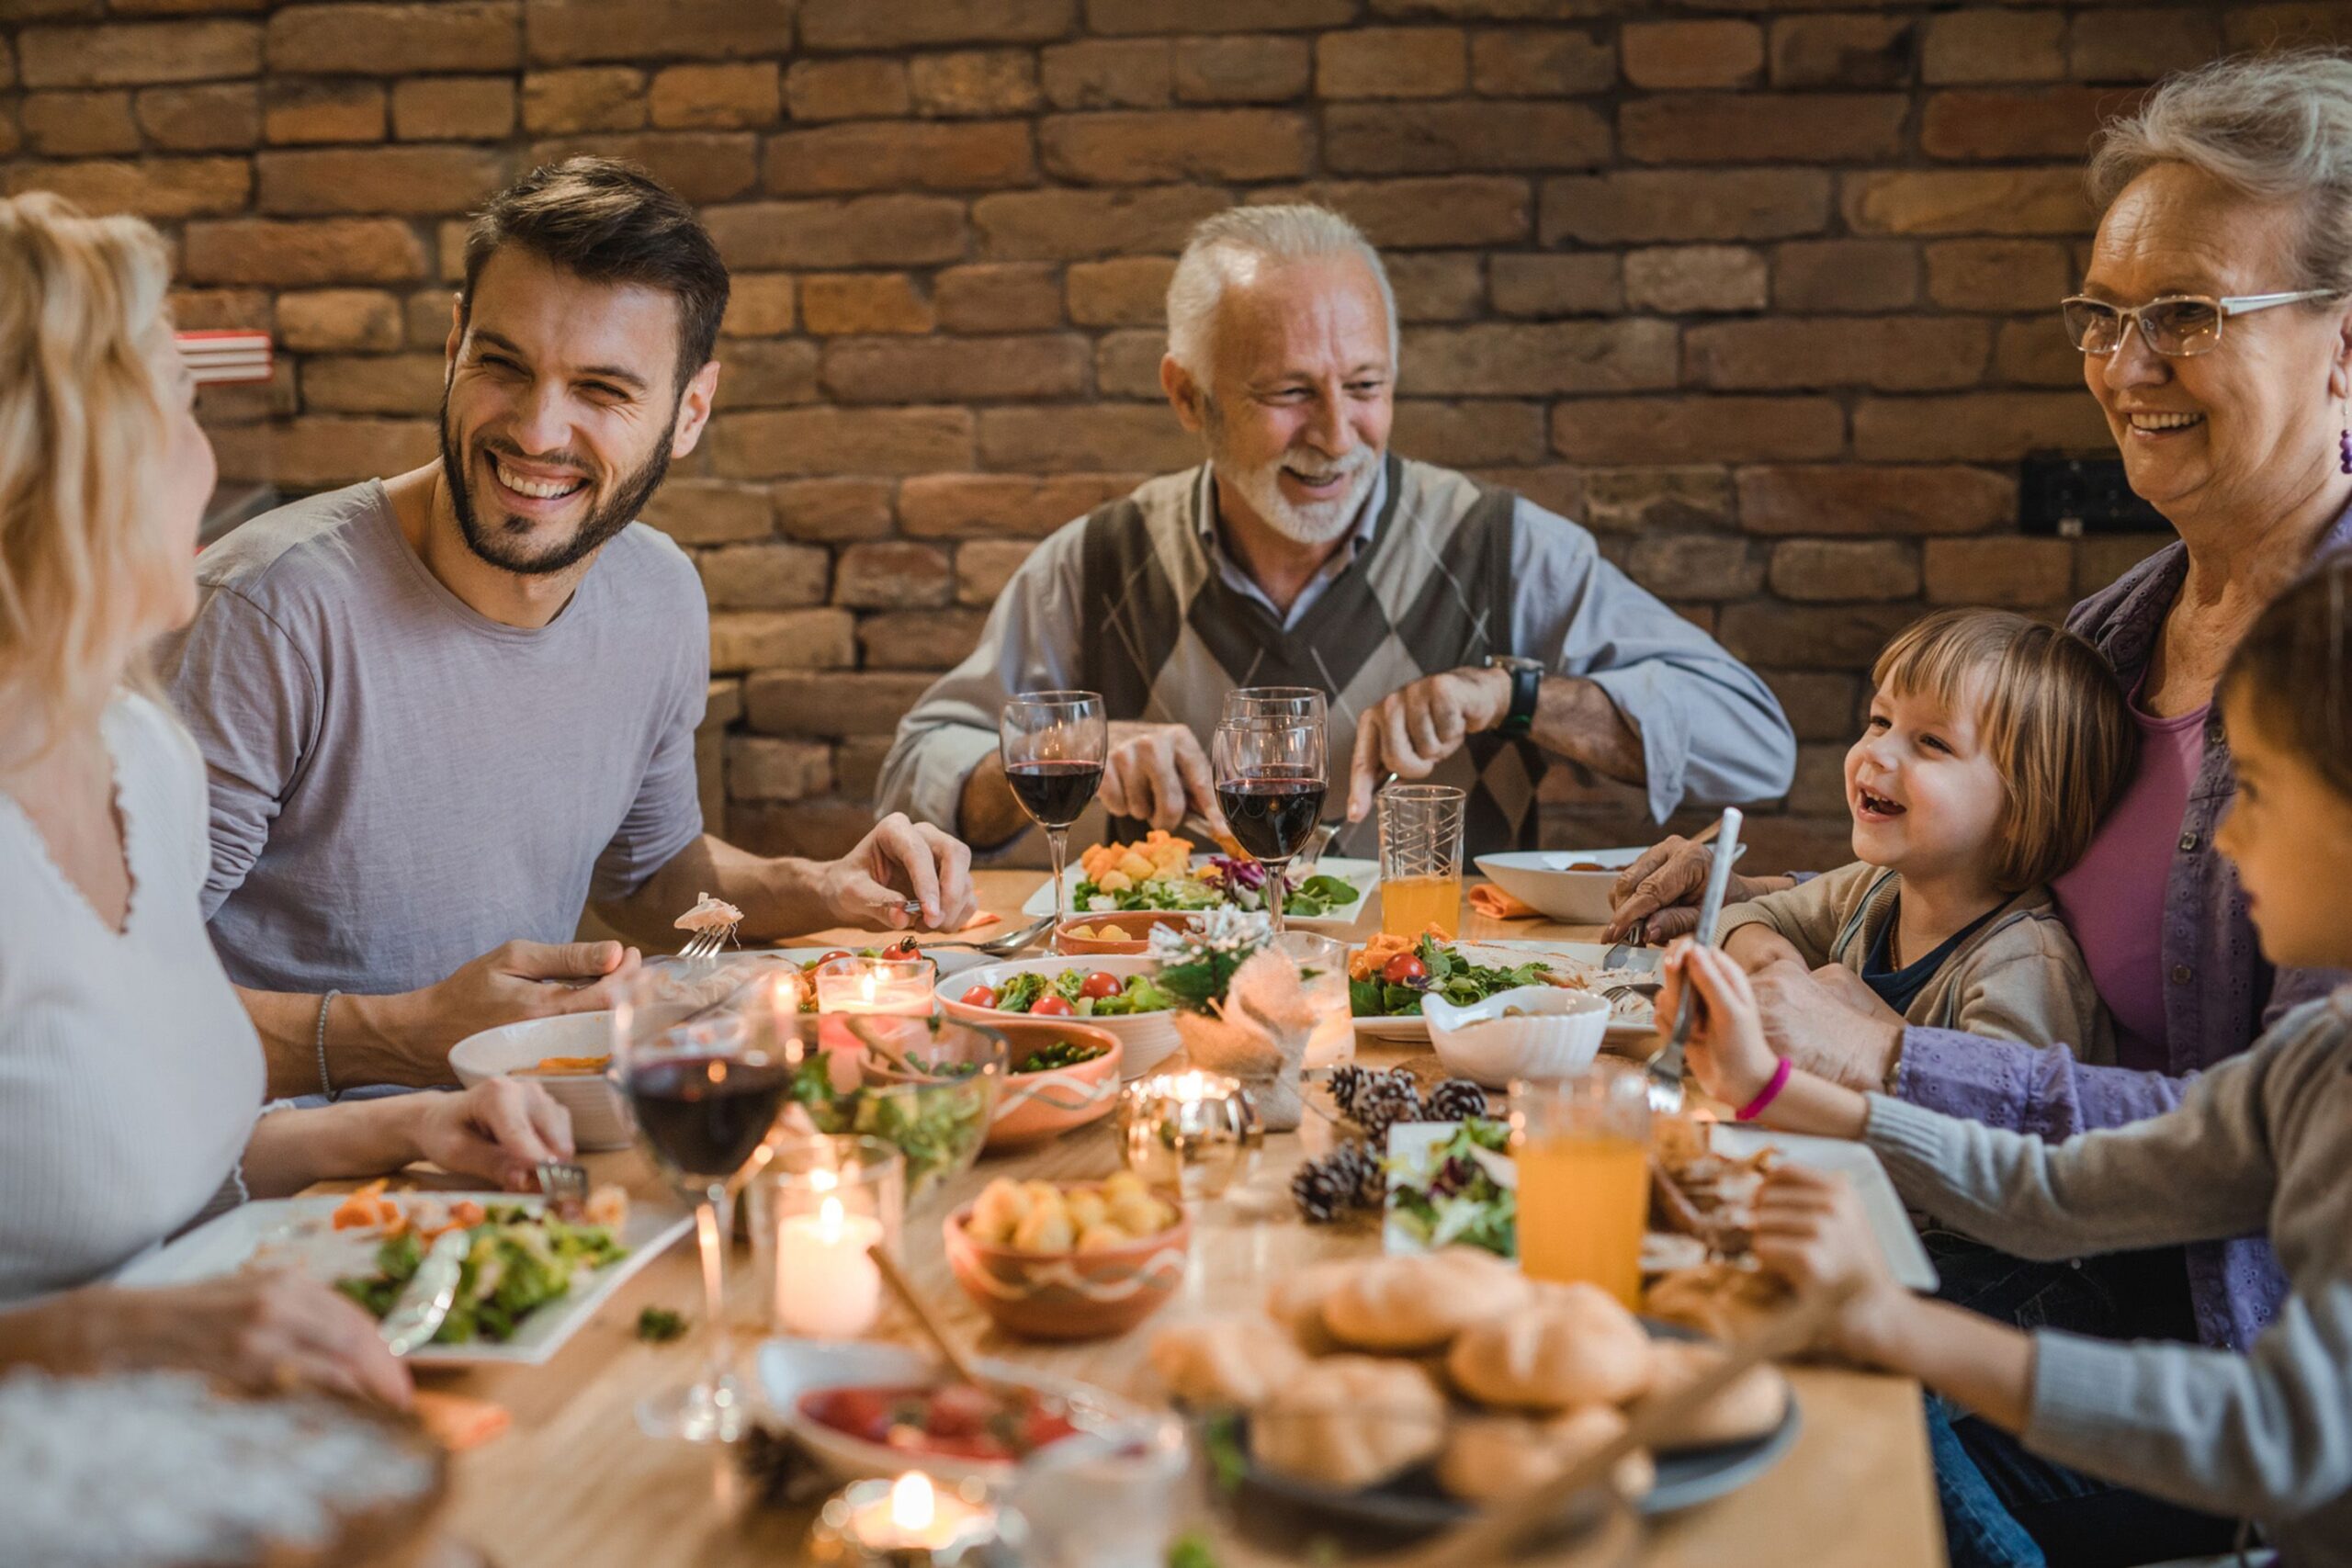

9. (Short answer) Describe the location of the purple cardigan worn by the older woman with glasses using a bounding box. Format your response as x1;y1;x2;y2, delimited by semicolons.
1895;510;2352;1349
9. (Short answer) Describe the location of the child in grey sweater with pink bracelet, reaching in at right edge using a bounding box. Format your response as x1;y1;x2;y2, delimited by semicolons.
1660;564;2352;1568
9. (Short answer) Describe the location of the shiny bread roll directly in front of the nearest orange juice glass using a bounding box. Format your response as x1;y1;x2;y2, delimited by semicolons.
1446;1286;1651;1411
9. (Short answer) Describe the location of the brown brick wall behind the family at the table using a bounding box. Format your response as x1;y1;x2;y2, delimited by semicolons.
0;0;2352;863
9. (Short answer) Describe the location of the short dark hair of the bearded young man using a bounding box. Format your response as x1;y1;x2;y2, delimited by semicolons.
457;157;727;388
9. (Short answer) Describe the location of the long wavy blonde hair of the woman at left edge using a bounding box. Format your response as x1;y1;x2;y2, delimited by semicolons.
0;193;178;761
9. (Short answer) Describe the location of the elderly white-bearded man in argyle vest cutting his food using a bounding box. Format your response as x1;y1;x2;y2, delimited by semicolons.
879;207;1797;853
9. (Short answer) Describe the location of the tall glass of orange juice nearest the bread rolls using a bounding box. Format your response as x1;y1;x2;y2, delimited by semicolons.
1510;1060;1649;1307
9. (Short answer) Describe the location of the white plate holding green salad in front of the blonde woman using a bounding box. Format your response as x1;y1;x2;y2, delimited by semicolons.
113;1192;694;1366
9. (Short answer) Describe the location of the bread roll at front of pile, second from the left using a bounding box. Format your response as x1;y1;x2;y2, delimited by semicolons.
1249;1357;1446;1491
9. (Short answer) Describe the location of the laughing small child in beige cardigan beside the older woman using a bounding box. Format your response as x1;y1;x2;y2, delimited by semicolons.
1722;609;2133;1063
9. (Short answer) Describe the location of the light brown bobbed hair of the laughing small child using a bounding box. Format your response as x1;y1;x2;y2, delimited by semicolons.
1870;609;2138;894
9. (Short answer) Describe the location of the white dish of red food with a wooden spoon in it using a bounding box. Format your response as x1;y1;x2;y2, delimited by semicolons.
760;1337;1152;1483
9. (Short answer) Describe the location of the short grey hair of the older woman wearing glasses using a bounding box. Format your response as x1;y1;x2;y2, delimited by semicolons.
2088;50;2352;294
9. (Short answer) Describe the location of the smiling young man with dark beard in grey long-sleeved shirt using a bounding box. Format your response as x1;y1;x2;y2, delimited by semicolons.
163;157;974;1093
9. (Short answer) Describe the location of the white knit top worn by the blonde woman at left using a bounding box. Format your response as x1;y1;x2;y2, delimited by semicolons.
0;694;264;1304
